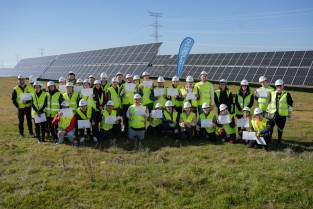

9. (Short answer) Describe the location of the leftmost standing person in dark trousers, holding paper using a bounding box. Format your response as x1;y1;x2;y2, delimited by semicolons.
11;74;35;137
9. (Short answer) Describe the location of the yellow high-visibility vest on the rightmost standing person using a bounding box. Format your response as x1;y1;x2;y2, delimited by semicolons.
269;90;289;116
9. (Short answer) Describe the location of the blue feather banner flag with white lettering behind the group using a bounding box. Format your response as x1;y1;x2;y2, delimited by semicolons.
176;37;194;77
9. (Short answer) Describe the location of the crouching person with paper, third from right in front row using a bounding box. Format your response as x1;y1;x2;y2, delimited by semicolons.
217;104;236;144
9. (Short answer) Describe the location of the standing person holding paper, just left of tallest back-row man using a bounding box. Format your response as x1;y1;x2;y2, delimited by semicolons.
177;76;198;115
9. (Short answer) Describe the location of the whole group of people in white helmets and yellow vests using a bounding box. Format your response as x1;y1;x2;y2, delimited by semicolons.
12;71;293;150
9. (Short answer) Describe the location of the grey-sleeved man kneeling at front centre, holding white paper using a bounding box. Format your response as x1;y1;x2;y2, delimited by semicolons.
126;94;149;140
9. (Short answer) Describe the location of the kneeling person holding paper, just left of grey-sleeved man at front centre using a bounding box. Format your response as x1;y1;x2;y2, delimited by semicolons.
99;101;121;140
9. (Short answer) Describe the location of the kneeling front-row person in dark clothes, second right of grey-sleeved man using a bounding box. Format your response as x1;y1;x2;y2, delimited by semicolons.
162;101;180;139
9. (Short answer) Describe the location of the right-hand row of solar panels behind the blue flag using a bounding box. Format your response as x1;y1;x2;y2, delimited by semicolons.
149;51;313;86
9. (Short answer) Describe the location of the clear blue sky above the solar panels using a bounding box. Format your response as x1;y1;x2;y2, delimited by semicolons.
0;0;313;68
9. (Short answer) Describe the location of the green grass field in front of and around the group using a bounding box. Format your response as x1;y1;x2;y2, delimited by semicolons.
0;78;313;208
